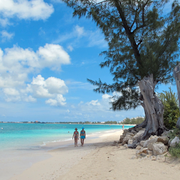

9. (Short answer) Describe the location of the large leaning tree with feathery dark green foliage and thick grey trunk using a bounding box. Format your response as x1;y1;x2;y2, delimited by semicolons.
63;0;180;143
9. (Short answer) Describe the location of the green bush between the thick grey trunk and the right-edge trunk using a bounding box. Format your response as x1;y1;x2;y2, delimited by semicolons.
159;88;180;129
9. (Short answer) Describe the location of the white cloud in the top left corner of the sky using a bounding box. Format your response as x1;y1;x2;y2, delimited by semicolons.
0;0;54;25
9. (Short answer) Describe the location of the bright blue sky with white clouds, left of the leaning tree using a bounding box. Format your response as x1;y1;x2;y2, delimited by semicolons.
0;0;177;122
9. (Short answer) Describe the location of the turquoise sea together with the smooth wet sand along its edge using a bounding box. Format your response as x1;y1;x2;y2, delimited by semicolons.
0;123;133;180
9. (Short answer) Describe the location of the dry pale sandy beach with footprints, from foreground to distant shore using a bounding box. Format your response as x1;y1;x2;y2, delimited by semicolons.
11;131;180;180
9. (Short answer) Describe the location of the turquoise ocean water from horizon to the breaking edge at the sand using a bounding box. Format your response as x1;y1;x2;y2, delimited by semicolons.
0;123;132;150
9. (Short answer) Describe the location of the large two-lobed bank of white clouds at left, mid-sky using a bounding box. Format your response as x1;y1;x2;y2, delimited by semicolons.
0;44;70;106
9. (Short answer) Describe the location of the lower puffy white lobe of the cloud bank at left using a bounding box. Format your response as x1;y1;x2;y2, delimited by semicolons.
3;75;68;106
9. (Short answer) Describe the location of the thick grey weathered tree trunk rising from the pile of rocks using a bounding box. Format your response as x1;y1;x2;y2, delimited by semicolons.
129;75;166;148
